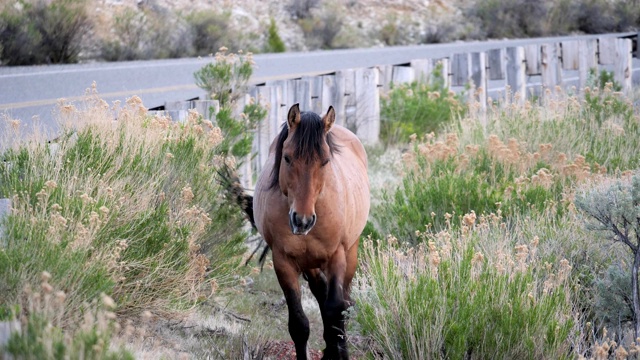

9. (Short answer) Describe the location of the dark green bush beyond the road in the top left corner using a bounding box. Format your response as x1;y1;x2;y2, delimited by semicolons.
0;0;91;65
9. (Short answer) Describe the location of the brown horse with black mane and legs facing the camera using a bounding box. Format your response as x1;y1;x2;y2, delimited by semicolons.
253;104;369;359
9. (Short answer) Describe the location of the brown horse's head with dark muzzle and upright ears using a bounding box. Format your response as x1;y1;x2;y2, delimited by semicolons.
273;104;336;235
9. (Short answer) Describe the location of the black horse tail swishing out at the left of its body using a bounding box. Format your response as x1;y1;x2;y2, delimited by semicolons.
218;164;269;269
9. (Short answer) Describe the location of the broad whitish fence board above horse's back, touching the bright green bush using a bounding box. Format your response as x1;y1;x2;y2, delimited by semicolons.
355;68;380;144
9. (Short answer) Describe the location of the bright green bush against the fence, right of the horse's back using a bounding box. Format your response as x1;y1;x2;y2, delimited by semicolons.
380;65;465;145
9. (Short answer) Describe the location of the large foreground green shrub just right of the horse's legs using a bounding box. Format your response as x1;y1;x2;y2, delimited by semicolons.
355;234;573;359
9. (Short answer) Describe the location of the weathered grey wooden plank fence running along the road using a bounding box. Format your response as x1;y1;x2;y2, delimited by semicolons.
159;34;640;188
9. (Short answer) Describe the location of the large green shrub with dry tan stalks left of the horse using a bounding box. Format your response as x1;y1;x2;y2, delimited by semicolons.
0;88;246;315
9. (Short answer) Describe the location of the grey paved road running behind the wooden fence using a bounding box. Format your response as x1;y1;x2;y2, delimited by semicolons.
0;33;633;138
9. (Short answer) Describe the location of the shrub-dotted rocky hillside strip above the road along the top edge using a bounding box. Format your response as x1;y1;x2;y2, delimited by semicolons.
0;0;640;65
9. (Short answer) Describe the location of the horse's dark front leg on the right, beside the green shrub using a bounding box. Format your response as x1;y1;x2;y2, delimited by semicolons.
322;246;349;359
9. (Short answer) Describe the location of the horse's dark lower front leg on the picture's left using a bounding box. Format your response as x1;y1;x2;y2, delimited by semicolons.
273;253;309;360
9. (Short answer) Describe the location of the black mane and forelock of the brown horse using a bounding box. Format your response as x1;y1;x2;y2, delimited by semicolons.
269;111;340;189
